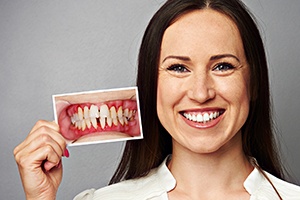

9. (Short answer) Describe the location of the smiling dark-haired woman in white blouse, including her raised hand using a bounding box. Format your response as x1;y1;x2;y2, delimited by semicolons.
14;0;300;199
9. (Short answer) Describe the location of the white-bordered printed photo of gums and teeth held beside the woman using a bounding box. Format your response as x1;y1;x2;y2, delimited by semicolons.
52;87;143;146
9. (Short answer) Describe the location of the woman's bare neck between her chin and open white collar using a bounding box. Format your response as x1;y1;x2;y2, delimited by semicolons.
168;133;253;199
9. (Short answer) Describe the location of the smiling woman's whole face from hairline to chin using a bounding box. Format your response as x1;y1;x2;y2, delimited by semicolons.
157;9;250;153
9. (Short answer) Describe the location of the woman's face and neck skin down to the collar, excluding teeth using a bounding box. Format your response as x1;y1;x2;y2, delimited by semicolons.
157;9;253;199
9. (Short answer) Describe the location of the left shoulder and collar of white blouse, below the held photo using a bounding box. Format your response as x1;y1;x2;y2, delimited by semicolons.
74;157;175;200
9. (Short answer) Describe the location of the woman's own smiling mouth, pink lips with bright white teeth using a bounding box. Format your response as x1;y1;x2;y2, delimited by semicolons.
180;108;225;128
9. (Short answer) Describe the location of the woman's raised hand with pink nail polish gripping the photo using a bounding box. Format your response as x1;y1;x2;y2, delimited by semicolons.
14;121;68;199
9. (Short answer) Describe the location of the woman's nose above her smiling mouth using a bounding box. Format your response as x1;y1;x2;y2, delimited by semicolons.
187;74;216;103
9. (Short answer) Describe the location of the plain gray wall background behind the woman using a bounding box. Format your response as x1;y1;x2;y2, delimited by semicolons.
0;0;300;199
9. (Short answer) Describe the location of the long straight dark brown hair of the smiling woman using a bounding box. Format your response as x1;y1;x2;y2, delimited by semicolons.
110;0;283;184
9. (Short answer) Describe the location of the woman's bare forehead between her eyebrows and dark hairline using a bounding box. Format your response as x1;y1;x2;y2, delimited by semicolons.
161;9;244;61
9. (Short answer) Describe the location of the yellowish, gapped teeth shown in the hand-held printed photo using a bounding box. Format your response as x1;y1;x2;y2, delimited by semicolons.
70;104;135;131
